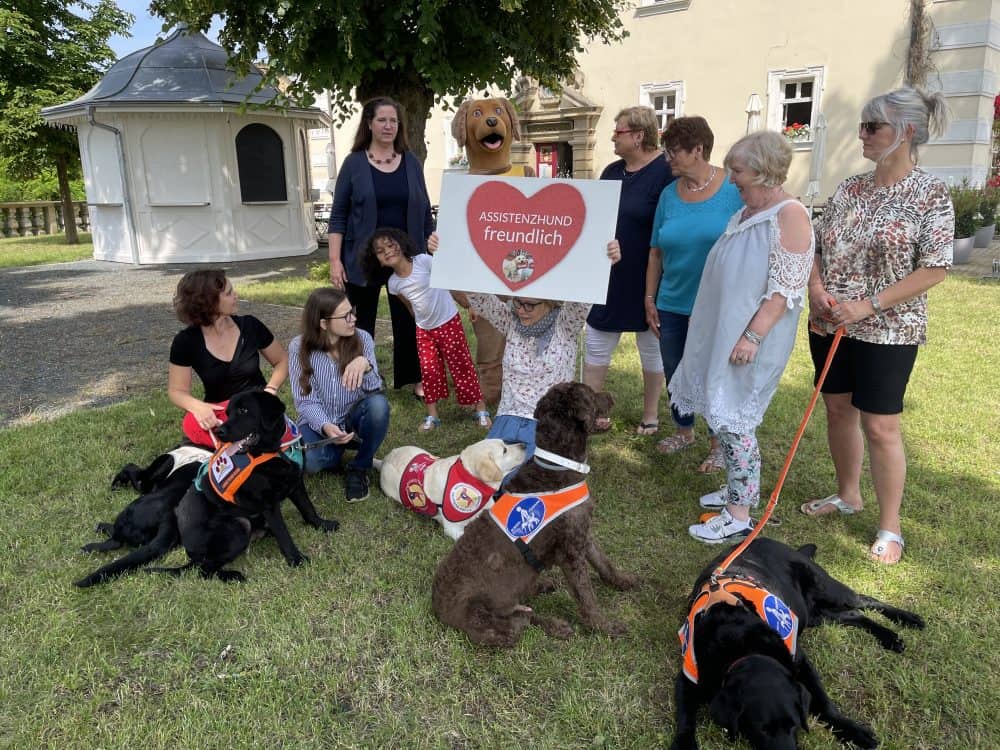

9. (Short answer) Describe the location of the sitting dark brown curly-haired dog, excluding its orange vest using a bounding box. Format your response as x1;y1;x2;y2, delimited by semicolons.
431;383;636;646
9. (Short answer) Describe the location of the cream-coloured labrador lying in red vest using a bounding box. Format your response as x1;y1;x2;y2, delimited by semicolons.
379;439;524;539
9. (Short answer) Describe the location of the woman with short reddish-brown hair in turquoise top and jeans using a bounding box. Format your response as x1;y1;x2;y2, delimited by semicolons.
645;117;743;473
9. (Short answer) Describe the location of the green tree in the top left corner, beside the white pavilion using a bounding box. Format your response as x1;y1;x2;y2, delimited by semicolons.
0;0;133;239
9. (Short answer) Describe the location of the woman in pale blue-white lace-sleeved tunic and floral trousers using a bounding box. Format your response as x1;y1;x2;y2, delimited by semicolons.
668;131;813;544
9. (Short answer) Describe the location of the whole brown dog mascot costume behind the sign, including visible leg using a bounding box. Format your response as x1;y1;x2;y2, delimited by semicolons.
451;99;535;404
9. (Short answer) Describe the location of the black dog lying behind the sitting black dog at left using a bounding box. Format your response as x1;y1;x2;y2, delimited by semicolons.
76;446;212;588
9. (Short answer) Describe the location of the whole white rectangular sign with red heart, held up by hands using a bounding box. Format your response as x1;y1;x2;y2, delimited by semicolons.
431;173;621;303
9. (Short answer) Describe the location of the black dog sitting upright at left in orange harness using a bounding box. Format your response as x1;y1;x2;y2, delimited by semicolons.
157;391;339;581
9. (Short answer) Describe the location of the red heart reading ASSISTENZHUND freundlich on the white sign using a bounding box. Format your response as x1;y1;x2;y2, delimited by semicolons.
465;182;587;291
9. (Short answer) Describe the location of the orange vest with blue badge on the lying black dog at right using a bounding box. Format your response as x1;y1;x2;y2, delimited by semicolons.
677;576;799;685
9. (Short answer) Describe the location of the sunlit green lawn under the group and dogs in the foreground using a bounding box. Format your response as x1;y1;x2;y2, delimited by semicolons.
0;277;1000;750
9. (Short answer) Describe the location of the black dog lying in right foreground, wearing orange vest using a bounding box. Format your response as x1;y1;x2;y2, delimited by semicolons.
671;538;924;750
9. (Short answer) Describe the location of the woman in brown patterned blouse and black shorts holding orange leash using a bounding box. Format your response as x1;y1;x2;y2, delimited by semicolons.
801;88;955;564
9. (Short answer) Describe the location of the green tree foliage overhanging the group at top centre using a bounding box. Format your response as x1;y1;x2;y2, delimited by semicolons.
152;0;631;158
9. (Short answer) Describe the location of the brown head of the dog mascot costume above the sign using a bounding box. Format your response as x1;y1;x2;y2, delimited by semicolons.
451;98;521;174
